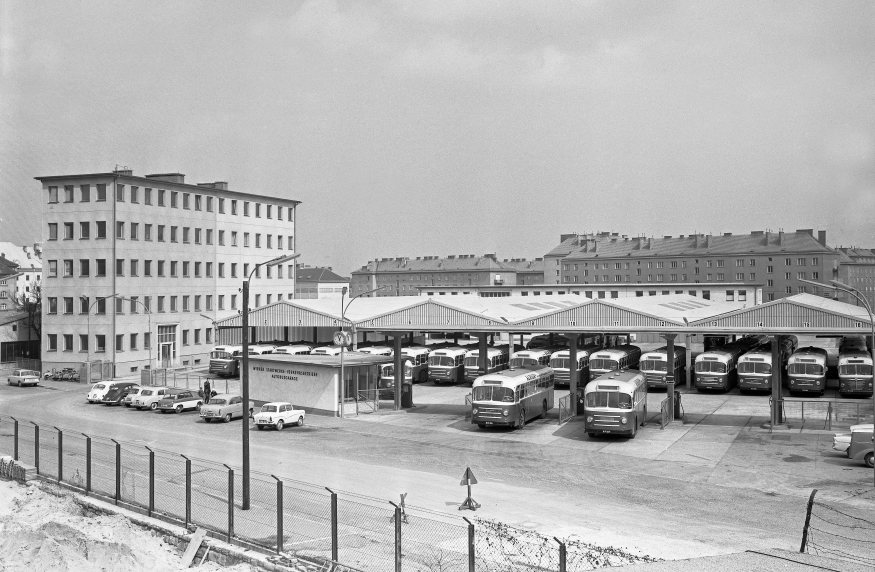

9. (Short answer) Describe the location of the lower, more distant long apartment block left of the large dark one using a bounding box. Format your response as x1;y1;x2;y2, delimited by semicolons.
351;254;518;296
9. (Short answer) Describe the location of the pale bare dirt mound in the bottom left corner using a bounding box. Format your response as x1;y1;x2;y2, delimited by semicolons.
0;481;252;572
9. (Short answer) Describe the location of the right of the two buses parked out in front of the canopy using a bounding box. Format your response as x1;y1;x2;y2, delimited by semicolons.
583;371;647;438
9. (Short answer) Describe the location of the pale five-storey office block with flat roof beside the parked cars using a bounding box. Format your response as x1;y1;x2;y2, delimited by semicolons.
37;170;299;375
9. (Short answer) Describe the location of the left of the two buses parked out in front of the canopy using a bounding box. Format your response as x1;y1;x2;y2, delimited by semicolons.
471;367;554;429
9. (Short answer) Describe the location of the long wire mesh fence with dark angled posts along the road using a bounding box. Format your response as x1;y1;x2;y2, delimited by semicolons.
0;417;652;572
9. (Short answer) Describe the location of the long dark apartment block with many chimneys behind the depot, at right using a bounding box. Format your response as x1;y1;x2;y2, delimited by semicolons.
545;229;839;302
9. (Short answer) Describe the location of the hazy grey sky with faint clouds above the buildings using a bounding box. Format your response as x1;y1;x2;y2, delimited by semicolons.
0;0;875;273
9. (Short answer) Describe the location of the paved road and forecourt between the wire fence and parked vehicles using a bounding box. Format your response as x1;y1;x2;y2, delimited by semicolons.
0;382;875;558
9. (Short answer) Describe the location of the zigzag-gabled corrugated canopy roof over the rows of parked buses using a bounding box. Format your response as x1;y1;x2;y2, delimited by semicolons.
216;294;870;335
